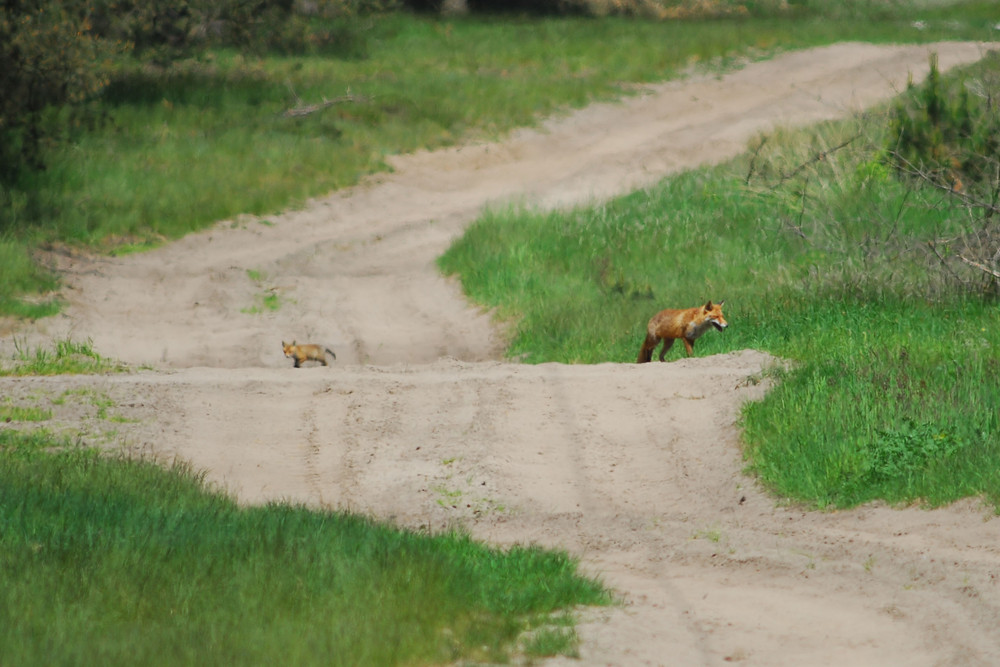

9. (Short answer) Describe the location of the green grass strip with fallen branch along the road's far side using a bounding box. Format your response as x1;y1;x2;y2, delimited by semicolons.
0;2;995;317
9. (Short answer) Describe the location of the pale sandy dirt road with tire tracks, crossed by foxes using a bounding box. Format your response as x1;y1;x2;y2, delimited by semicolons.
0;43;1000;666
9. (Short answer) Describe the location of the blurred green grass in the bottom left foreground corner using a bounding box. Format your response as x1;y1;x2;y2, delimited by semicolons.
0;431;612;665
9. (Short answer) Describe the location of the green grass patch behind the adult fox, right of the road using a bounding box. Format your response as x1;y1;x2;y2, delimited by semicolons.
439;53;1000;507
